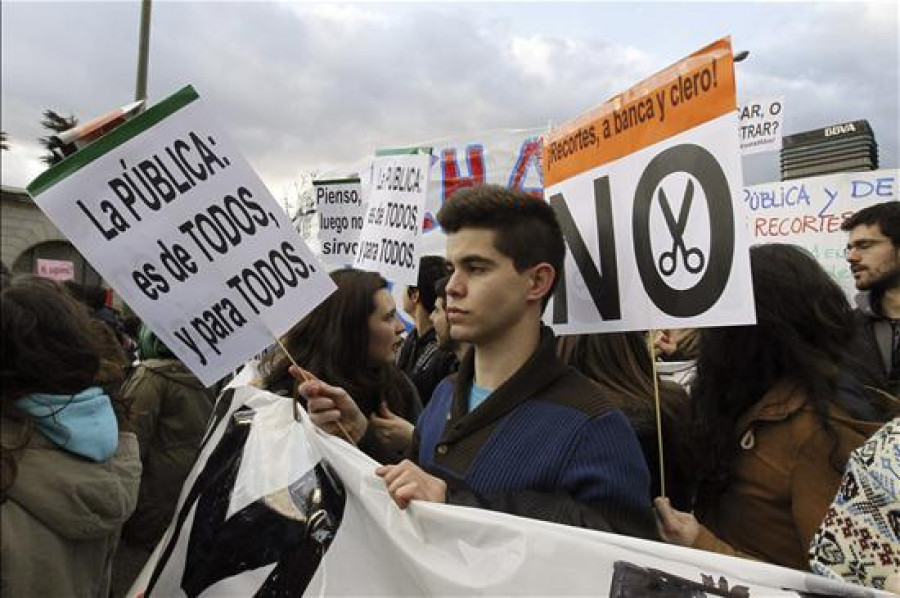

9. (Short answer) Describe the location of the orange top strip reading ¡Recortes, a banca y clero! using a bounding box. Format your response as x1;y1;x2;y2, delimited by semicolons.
544;37;737;187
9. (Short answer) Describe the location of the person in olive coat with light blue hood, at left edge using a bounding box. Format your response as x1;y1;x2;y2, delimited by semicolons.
0;276;141;598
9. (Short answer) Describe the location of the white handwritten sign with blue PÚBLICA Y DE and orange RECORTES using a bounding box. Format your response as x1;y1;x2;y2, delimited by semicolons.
741;168;900;297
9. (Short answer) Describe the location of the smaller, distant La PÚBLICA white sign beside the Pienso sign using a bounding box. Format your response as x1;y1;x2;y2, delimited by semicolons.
355;152;431;286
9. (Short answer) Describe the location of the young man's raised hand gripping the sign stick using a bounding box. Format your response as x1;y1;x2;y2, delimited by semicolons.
288;366;369;443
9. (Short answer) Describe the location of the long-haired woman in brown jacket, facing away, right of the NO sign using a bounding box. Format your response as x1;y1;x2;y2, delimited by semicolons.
656;244;896;570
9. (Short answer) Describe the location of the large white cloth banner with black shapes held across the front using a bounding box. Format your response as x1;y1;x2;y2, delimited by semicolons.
128;386;887;598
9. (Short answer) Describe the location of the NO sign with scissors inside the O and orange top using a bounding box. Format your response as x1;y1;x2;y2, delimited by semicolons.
544;38;755;334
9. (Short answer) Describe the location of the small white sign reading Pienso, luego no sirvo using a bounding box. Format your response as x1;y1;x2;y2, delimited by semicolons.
313;179;365;266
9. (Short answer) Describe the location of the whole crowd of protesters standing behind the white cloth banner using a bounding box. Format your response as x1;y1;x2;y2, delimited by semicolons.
0;185;900;598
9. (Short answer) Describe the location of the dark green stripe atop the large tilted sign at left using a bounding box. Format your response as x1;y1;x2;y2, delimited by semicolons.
25;85;200;197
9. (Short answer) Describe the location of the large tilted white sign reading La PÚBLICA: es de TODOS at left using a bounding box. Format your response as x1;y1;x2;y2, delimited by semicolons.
28;86;334;385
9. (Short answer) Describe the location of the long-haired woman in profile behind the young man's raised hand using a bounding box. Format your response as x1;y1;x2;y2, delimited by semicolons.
260;269;422;463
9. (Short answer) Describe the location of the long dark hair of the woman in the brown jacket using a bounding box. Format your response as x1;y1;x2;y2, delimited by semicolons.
691;244;886;509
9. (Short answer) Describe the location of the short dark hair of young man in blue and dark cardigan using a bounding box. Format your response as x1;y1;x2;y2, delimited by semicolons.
437;185;566;305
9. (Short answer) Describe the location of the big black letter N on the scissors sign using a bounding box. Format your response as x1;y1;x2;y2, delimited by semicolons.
550;176;622;324
